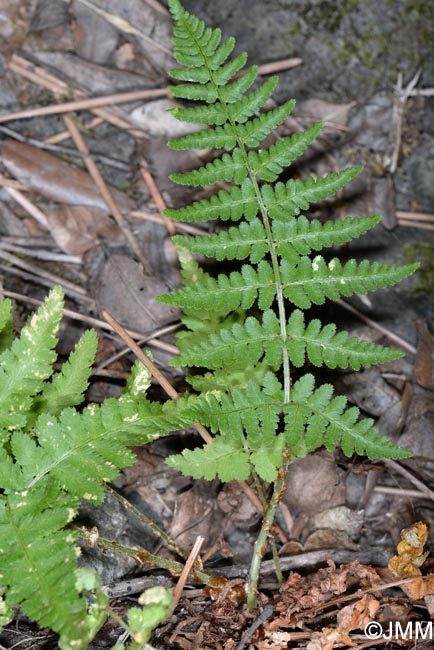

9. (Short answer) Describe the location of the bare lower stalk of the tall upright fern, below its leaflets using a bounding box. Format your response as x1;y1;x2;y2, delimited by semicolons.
247;465;286;611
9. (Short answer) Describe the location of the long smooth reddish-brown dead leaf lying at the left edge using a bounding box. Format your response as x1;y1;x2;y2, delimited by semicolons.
0;140;131;211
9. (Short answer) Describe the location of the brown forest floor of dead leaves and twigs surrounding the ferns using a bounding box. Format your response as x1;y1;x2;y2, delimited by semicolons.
0;0;434;650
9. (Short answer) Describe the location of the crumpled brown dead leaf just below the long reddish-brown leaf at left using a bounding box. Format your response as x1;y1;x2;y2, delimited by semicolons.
44;205;120;255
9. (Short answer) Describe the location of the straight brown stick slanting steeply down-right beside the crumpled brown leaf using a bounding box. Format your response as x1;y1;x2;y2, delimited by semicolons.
63;116;149;270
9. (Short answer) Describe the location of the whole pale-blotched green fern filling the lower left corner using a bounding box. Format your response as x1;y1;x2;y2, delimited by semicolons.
0;289;185;650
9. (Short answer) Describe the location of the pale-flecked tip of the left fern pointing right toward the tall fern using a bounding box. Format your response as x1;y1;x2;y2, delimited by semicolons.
23;396;190;503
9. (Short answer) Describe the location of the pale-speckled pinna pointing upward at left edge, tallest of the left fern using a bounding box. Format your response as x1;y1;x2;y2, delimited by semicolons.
0;288;63;430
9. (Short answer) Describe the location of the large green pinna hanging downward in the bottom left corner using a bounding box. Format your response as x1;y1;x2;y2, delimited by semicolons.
0;483;89;650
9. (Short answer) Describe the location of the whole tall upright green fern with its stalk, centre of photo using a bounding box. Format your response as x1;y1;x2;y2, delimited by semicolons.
160;0;416;607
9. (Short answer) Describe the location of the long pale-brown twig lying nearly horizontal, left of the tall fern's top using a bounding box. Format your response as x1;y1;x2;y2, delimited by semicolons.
0;88;169;122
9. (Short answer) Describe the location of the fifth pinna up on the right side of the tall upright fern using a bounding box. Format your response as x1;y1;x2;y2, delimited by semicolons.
261;167;361;221
